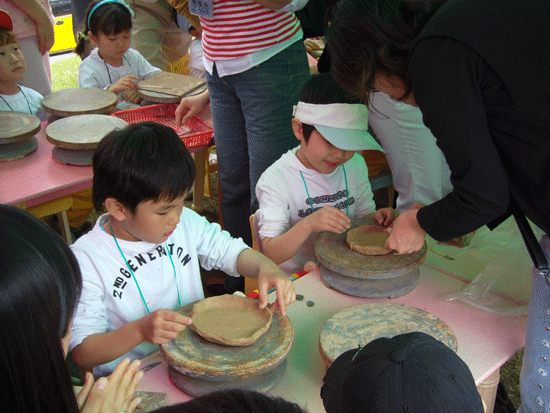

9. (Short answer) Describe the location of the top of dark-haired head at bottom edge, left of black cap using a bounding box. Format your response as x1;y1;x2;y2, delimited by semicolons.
155;389;306;413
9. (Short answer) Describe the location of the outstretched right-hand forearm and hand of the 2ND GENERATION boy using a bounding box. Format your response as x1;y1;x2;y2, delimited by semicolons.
237;248;296;315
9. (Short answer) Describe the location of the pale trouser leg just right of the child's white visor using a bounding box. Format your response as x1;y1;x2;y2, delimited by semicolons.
369;92;452;212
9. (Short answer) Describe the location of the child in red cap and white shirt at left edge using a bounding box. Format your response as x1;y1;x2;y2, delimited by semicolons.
0;10;46;120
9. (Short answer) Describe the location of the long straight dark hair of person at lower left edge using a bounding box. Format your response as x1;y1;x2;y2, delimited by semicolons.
0;205;82;413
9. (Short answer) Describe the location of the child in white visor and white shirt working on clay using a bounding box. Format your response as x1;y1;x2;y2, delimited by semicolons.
254;73;395;274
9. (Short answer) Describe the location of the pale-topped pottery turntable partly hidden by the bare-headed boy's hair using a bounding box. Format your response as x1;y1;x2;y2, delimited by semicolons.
46;115;128;165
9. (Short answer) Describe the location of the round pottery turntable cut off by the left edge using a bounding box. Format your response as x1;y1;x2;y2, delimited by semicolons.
0;111;40;162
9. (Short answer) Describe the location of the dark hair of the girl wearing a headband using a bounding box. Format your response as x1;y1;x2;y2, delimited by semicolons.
74;0;132;58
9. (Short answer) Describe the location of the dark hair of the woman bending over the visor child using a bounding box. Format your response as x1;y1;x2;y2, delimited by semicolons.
327;0;446;103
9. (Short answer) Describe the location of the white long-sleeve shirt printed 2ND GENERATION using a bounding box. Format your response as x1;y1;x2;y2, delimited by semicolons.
69;208;248;377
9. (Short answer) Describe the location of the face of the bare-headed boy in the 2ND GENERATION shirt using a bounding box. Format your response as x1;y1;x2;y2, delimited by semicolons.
114;195;185;244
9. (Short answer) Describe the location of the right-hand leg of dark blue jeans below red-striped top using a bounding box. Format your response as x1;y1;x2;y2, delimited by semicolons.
235;42;310;213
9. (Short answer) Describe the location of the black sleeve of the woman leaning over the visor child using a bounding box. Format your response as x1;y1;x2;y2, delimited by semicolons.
409;38;509;241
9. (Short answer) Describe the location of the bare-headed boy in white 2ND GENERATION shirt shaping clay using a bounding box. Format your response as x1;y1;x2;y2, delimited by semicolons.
70;122;296;376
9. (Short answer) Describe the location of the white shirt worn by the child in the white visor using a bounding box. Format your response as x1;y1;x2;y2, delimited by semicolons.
256;146;376;274
